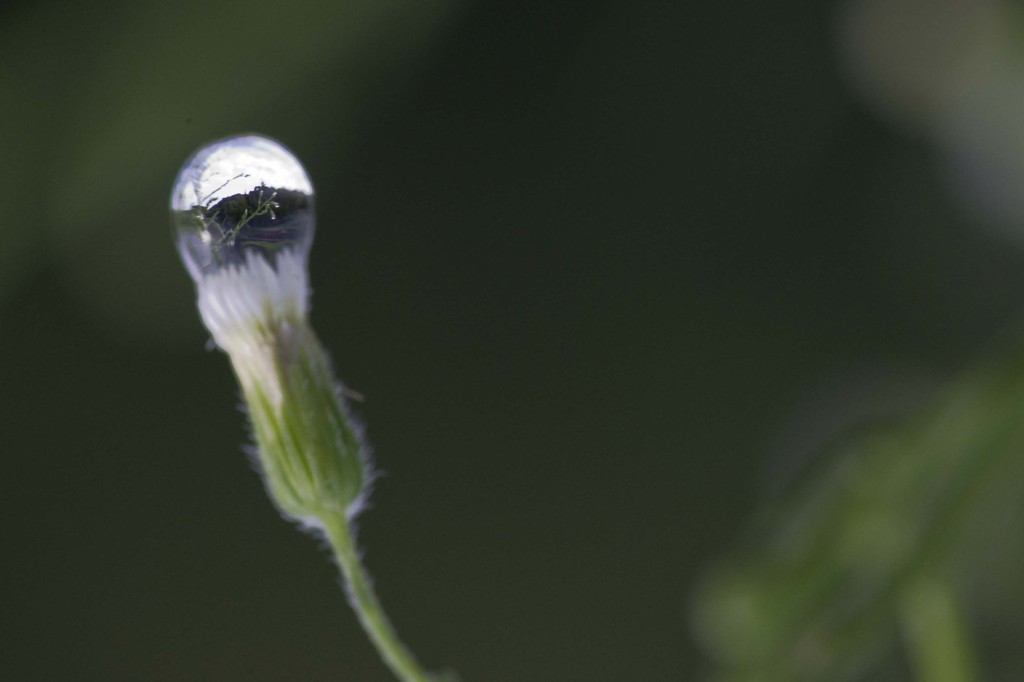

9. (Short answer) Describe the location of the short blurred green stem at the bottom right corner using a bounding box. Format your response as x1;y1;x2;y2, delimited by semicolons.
899;576;979;682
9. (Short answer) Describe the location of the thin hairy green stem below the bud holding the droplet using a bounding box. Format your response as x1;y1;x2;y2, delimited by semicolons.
321;512;433;682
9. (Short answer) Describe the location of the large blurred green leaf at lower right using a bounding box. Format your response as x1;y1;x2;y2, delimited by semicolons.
695;327;1024;681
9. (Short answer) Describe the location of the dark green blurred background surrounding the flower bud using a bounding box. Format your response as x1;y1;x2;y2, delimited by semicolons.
0;0;1024;682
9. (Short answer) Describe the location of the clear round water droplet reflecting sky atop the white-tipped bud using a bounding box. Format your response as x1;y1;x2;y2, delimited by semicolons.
171;135;315;281
